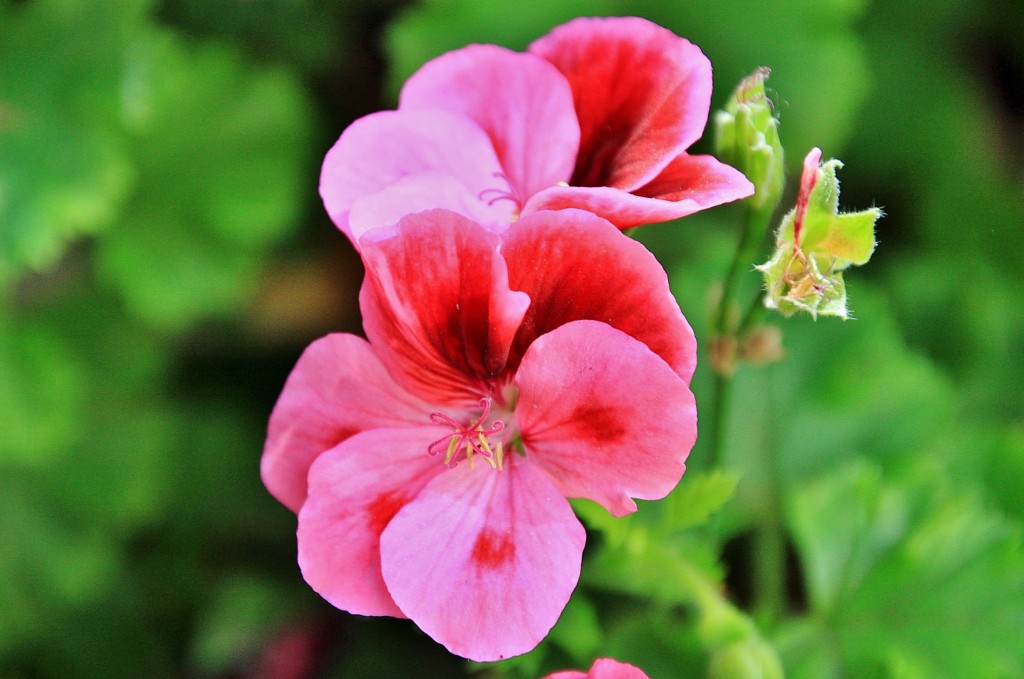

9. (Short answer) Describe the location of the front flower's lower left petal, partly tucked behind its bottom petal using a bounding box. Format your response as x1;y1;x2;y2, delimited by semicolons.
298;426;445;618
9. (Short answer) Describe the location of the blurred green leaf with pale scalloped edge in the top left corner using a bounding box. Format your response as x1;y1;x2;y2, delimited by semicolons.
0;0;148;282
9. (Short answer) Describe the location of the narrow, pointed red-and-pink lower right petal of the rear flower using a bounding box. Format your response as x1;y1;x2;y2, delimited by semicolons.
523;154;754;228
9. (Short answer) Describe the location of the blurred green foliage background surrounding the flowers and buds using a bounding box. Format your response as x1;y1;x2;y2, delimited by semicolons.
0;0;1024;679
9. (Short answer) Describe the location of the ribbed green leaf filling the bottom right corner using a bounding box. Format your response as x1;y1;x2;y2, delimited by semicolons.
786;461;1024;679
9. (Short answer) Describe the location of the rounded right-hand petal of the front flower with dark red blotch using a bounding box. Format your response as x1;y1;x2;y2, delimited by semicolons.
516;321;697;516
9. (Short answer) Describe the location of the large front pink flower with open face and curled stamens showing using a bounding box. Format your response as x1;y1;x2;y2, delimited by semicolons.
261;210;696;661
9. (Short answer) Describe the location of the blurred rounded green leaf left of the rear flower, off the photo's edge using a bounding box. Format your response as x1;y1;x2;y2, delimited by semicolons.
97;34;310;331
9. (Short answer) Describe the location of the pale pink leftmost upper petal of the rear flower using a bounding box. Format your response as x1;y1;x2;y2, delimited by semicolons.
319;111;511;244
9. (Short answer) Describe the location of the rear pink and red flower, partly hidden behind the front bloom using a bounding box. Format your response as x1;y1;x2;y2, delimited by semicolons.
321;17;754;242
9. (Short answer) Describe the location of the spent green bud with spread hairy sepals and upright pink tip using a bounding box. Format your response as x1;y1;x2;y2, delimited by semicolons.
757;148;882;319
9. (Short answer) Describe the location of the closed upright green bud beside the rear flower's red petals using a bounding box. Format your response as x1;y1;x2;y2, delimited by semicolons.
715;67;785;210
